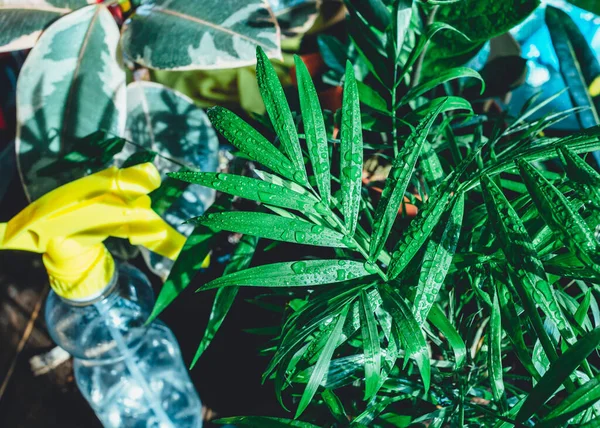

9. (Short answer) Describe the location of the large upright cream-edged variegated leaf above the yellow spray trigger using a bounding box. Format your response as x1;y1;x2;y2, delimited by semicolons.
16;5;125;199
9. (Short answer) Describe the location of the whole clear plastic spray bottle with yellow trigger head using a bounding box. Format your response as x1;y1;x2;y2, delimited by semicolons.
0;163;202;428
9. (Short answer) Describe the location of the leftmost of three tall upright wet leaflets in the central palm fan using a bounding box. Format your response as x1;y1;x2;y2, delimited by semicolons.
256;46;308;184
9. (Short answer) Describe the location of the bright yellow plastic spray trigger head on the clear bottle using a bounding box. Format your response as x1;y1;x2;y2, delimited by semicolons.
0;163;185;300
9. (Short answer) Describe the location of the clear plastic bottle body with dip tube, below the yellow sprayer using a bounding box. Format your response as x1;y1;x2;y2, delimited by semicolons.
46;264;202;428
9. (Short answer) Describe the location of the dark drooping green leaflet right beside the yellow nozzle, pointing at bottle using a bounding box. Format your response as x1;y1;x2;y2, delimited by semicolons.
146;199;229;323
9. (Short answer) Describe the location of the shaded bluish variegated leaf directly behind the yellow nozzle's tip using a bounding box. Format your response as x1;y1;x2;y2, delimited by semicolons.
125;82;219;273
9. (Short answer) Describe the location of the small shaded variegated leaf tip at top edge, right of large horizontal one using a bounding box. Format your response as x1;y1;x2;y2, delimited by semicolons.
268;0;321;38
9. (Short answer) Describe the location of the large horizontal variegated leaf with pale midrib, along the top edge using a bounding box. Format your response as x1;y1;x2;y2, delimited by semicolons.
123;0;281;70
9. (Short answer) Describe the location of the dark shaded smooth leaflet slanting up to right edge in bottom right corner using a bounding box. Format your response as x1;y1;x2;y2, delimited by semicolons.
515;328;600;423
